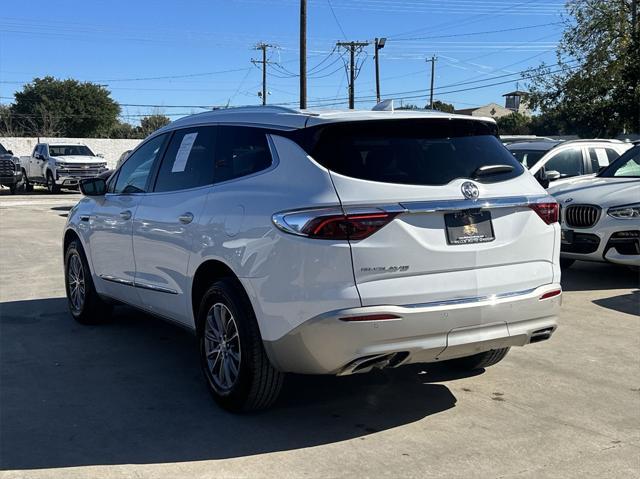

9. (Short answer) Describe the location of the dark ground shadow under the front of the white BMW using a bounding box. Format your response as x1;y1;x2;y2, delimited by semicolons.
561;261;640;291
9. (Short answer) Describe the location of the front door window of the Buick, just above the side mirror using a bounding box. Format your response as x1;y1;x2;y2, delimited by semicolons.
113;134;167;194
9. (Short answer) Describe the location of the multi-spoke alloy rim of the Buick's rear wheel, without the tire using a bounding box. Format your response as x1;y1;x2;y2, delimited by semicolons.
204;303;241;394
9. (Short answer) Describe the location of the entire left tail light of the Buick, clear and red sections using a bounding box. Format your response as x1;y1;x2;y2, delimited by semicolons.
273;208;397;240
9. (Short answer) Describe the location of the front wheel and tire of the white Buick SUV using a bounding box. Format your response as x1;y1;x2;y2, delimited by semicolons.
64;239;112;324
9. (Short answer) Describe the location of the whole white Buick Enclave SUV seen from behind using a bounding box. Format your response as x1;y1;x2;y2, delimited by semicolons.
64;107;561;410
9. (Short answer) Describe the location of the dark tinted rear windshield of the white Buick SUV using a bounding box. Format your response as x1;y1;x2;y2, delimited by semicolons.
306;119;524;185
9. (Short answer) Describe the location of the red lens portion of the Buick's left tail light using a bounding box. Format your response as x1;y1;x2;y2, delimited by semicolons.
300;212;396;240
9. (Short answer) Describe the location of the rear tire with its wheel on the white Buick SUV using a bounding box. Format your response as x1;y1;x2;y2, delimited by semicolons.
198;279;284;412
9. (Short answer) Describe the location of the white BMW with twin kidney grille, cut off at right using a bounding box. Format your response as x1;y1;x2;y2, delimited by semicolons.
549;145;640;268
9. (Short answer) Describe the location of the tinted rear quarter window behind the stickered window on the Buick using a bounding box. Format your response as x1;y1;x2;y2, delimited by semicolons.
214;126;271;183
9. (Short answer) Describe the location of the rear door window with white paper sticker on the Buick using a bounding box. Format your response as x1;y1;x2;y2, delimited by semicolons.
154;126;216;191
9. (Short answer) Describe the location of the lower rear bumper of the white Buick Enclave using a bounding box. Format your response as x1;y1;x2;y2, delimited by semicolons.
265;284;562;374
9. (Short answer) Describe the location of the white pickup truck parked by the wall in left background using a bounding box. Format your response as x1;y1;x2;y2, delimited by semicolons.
20;143;107;193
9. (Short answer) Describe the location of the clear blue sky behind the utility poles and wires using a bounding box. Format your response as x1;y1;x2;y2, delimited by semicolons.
0;0;564;123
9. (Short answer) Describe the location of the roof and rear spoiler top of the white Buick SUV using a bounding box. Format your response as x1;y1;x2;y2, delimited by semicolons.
158;106;494;131
